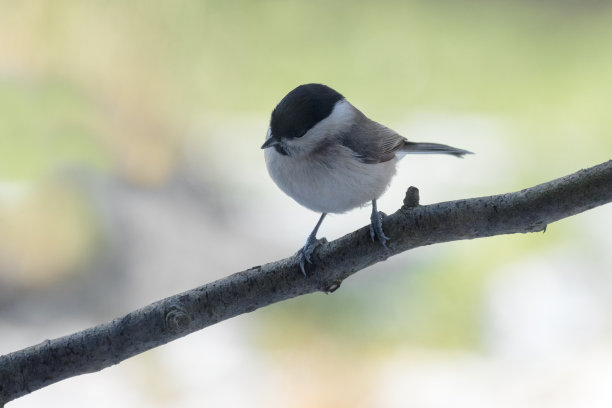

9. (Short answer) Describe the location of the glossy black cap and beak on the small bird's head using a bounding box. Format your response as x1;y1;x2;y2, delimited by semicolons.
261;84;344;149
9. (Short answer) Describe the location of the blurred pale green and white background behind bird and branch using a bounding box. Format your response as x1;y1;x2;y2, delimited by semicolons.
0;0;612;408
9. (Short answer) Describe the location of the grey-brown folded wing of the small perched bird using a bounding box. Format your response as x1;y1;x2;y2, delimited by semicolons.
339;114;406;164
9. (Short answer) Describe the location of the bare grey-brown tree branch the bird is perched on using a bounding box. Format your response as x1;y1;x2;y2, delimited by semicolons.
0;160;612;406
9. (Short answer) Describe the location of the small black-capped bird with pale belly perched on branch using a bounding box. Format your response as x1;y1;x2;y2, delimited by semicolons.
261;84;471;276
